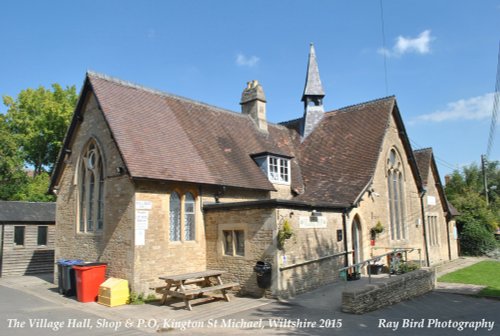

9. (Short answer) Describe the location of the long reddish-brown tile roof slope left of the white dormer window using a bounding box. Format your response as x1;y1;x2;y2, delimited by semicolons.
88;73;301;190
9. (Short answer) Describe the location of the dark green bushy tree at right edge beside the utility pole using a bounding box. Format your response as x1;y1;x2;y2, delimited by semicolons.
446;161;500;255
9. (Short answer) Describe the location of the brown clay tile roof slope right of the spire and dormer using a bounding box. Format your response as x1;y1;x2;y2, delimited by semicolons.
297;97;395;204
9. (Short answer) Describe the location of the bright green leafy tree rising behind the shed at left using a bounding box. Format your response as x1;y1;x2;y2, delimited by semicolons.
3;84;78;176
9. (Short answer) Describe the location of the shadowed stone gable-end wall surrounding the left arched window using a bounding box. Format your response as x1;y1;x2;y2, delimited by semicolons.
55;95;134;282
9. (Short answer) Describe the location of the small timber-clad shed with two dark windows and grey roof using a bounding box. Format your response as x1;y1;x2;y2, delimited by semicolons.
0;201;56;277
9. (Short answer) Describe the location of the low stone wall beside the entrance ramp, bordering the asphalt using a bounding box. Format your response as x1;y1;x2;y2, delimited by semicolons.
342;269;436;314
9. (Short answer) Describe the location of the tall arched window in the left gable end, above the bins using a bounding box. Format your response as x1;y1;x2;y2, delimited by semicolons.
78;140;104;232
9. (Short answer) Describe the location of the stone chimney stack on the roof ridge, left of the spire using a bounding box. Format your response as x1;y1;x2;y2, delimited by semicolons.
240;80;267;133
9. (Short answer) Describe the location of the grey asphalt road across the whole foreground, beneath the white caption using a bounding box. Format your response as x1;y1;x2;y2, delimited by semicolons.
0;286;500;336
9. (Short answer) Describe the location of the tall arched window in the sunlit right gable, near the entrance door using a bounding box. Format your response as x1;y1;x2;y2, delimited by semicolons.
387;149;406;240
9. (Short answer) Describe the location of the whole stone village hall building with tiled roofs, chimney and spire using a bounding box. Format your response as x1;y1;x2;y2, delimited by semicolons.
51;45;458;296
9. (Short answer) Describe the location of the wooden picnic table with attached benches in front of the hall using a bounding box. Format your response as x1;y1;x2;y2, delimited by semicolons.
155;270;239;310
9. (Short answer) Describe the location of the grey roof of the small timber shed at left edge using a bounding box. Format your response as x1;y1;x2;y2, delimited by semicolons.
0;201;56;224
